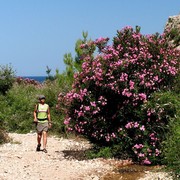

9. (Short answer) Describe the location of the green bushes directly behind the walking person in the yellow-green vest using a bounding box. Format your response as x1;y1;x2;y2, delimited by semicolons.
0;80;65;134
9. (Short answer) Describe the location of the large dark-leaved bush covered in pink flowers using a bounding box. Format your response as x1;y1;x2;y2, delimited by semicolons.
64;27;180;164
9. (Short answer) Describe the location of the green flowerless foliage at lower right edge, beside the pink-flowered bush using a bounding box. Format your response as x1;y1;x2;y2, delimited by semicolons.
163;93;180;179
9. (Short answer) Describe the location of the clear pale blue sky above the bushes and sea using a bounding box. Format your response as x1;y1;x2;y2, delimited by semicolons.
0;0;180;76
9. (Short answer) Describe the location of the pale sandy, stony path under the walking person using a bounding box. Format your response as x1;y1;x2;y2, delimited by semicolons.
0;133;171;180
